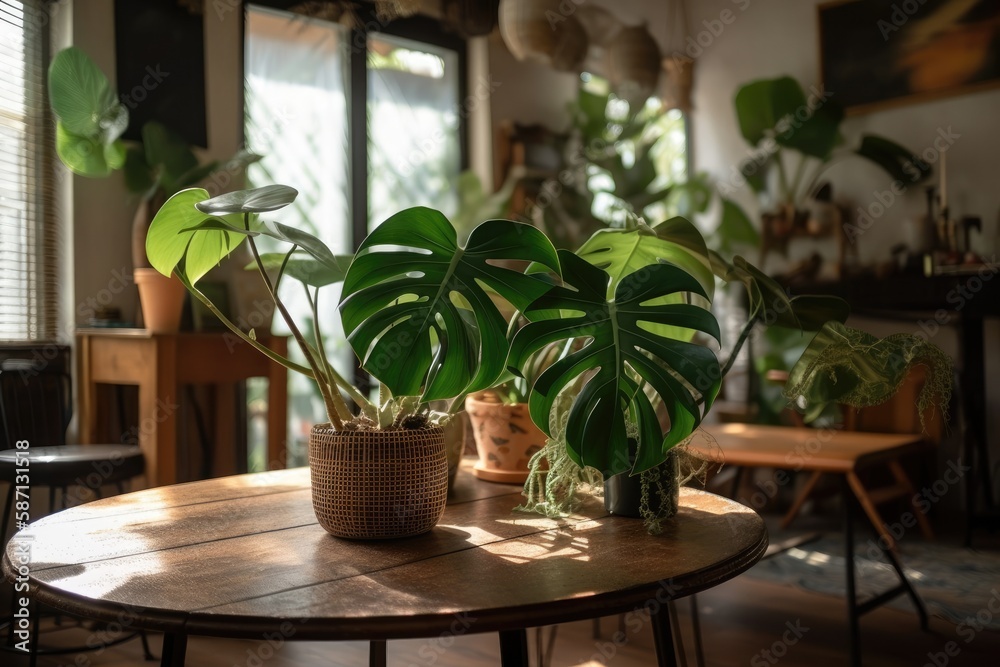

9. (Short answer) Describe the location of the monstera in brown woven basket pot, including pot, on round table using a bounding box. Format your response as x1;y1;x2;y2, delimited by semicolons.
146;186;559;539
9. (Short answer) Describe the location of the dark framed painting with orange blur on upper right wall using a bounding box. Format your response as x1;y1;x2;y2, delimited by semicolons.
818;0;1000;114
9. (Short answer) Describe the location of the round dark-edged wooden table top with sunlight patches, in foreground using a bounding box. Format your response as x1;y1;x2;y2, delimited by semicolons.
3;462;767;640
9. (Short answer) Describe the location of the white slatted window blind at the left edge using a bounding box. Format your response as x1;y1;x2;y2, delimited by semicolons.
0;0;60;342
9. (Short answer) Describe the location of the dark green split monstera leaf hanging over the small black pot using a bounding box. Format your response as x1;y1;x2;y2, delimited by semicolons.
508;251;720;475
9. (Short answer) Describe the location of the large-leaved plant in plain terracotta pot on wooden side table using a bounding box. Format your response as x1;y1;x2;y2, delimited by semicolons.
48;46;260;331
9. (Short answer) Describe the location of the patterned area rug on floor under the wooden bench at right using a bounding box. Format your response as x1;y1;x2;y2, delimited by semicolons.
747;535;1000;630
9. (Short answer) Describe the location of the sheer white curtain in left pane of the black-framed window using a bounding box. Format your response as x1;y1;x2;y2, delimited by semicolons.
244;5;352;465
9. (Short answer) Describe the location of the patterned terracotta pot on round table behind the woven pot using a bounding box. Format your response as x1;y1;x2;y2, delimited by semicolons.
465;394;545;484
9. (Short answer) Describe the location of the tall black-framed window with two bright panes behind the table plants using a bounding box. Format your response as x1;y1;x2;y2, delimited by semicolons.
244;3;465;465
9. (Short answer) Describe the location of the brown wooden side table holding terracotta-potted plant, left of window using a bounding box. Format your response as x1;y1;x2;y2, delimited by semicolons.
76;329;288;486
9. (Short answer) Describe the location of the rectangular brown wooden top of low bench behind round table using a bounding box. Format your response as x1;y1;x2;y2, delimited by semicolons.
687;424;926;473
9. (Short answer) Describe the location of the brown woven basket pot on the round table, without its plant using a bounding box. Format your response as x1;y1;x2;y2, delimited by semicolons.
309;424;448;540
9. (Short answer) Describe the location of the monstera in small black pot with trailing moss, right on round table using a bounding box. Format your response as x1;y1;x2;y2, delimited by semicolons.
508;218;951;532
